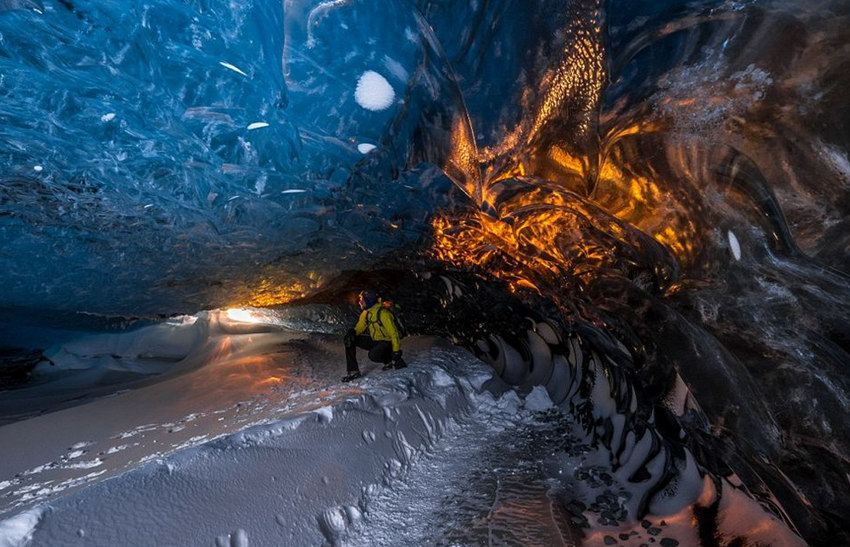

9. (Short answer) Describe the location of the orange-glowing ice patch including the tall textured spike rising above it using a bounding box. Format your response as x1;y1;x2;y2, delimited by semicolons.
422;9;700;308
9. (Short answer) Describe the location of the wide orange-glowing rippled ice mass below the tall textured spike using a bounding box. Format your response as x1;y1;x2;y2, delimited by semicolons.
432;147;697;302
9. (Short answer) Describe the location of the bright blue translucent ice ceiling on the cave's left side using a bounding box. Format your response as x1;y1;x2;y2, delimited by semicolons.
0;2;476;313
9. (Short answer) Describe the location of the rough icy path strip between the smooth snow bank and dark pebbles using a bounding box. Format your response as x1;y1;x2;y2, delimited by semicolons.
343;398;581;545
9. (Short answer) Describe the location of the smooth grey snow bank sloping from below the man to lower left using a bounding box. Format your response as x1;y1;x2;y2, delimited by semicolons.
0;348;504;547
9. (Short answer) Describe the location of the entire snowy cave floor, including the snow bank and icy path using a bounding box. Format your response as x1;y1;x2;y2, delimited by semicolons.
0;312;800;547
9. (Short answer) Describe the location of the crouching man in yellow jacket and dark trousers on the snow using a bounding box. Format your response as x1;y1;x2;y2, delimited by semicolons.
342;291;407;382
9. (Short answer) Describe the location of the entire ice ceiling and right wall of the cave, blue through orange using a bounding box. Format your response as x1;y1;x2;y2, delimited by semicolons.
0;0;850;541
